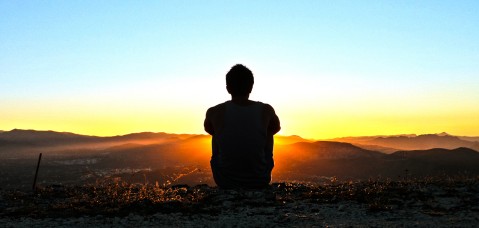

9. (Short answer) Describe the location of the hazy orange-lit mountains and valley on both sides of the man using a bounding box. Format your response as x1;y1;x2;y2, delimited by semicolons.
0;130;479;186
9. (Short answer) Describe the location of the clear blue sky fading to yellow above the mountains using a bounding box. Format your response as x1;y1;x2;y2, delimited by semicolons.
0;0;479;139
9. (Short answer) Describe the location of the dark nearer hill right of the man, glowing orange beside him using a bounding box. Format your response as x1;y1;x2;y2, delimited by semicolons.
275;141;479;181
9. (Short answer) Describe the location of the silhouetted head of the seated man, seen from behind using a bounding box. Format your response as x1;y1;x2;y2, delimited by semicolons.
226;64;254;96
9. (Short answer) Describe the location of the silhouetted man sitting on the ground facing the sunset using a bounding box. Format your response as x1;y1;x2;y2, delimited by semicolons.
204;64;281;189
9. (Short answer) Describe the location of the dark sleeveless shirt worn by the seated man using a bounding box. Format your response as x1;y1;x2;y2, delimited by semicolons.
211;101;274;188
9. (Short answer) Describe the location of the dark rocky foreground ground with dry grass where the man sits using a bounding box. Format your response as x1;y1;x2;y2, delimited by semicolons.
0;177;479;227
